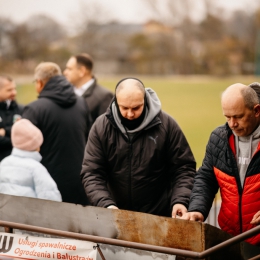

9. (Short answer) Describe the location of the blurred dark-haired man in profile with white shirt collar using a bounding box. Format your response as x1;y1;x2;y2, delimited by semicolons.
63;53;113;122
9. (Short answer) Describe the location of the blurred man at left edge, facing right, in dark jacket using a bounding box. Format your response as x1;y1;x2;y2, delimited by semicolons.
0;75;23;161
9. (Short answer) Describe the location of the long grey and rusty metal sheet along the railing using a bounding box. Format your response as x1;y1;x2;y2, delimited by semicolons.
0;194;256;259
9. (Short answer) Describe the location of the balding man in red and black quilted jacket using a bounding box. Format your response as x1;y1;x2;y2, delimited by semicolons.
182;83;260;246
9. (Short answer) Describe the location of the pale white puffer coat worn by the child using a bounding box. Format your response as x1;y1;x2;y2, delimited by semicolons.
0;148;61;201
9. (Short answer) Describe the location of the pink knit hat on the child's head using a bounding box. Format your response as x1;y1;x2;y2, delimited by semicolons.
11;119;43;151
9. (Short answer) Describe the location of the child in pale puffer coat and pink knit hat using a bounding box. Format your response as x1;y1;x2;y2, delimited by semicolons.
0;119;62;201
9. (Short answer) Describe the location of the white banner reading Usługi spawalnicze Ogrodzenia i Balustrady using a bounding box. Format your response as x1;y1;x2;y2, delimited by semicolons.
0;232;97;260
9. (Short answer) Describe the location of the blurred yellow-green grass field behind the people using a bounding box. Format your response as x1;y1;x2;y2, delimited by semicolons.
17;76;259;167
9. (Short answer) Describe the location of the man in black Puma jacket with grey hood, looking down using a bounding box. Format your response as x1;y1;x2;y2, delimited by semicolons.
81;78;196;217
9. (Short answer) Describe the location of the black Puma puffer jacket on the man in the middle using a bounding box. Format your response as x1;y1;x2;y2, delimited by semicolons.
81;95;196;216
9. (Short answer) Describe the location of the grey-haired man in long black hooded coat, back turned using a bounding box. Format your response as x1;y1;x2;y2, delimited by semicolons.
23;62;89;205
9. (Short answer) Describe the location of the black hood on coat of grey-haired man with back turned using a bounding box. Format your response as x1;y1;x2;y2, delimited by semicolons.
38;76;77;107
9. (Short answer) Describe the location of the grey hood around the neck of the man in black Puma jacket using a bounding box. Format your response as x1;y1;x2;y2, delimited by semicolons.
111;88;161;136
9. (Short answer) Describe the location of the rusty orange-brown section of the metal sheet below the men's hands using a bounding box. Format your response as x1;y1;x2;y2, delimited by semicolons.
113;210;204;252
